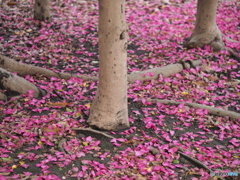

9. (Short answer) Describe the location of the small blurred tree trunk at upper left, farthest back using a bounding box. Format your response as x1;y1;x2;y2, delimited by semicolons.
34;0;50;21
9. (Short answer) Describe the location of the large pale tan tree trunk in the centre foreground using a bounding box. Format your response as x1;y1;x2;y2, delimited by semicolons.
87;0;129;131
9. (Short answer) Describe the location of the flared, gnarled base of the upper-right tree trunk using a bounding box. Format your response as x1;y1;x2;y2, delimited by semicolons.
185;27;225;51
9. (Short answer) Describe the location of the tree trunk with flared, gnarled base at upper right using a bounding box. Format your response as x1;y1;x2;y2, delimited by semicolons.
187;0;224;51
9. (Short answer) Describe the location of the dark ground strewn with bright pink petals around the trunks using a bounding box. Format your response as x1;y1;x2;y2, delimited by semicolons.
0;0;240;180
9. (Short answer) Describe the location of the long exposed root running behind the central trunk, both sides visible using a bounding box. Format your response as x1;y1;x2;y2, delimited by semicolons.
0;55;202;83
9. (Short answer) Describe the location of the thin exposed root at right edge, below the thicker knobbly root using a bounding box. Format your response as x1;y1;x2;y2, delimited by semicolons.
147;99;240;120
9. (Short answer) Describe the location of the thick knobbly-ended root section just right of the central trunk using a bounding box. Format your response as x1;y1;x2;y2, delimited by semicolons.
128;60;202;83
